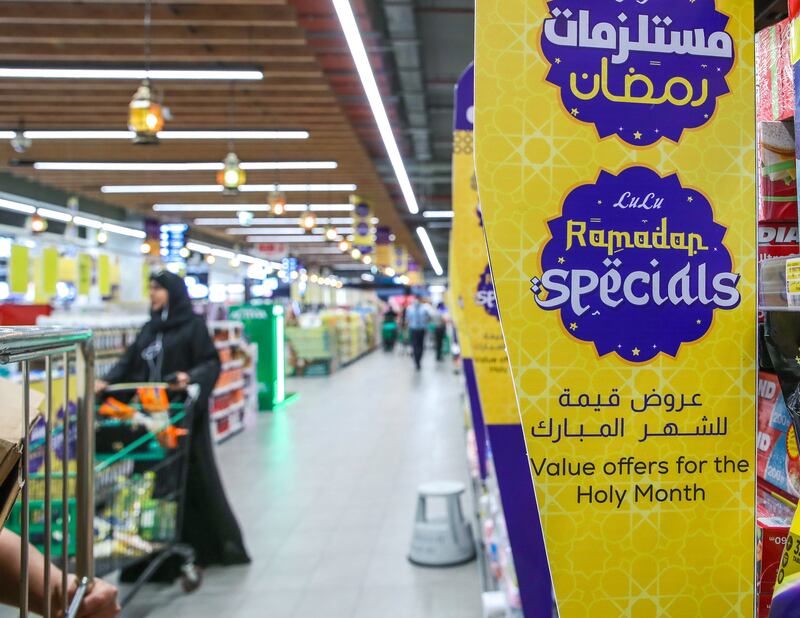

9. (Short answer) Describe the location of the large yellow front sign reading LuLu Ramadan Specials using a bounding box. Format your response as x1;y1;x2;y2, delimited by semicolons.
475;0;757;618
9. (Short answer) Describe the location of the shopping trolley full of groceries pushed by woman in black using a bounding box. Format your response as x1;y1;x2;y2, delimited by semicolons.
94;383;201;607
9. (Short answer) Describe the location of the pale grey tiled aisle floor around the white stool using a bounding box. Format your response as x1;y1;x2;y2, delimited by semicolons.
123;352;481;618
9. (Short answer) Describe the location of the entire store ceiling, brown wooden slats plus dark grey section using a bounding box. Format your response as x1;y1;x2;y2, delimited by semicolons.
0;0;786;274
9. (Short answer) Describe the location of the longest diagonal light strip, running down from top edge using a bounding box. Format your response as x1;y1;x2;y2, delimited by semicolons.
333;0;419;214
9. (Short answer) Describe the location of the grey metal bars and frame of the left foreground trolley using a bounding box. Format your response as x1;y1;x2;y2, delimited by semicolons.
0;327;95;618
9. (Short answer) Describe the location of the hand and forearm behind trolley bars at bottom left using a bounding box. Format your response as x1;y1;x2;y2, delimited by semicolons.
0;530;121;618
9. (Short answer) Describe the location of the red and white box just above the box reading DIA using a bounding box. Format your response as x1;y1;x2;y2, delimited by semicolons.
758;120;797;224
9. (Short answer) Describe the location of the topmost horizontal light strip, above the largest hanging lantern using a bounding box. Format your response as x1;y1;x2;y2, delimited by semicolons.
0;67;264;81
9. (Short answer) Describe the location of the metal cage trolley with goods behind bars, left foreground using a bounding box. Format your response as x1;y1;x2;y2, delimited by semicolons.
0;327;94;618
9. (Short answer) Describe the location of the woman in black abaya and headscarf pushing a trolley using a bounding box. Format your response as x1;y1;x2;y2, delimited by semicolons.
97;271;250;581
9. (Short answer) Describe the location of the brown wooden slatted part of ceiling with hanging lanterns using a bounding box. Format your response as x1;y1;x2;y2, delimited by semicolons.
0;0;444;266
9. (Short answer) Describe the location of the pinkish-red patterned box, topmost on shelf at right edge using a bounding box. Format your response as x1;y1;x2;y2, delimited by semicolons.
756;19;794;120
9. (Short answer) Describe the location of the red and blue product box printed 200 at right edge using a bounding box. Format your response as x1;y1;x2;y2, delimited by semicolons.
757;371;800;498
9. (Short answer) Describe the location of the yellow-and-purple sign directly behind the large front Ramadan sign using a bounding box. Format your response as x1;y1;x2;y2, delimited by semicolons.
450;66;553;618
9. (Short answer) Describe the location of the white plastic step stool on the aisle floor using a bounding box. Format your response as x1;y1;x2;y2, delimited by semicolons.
408;481;475;567
